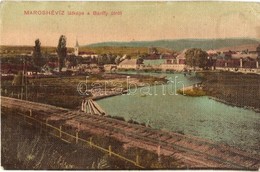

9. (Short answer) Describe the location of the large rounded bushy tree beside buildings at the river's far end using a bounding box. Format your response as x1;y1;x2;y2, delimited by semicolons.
185;48;208;68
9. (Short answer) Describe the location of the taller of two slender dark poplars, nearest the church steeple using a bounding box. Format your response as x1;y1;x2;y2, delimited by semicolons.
56;35;67;72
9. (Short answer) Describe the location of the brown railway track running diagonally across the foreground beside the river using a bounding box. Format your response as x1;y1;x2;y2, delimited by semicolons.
1;97;260;169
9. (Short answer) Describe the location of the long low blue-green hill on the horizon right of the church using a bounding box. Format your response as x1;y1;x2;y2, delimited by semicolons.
84;38;260;51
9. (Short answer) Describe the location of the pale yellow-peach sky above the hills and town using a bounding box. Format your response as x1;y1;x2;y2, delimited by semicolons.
0;1;260;47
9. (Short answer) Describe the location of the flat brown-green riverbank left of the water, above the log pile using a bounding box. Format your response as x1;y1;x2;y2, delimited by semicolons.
1;73;166;109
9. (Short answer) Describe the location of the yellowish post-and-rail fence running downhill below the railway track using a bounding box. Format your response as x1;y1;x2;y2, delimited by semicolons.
13;110;144;169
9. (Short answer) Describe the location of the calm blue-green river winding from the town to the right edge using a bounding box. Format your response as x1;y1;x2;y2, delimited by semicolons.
98;73;260;154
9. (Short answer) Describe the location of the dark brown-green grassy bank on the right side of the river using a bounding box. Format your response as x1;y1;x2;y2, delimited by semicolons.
197;72;260;112
